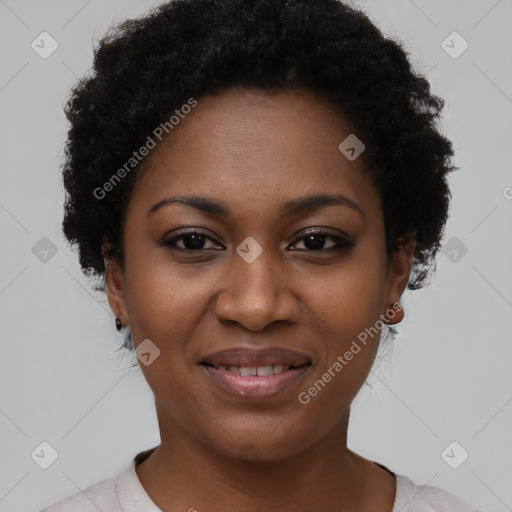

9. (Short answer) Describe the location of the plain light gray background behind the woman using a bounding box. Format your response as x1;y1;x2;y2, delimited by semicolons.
0;0;512;512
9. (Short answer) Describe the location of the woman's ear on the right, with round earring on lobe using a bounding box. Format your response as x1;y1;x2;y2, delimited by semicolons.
386;231;416;325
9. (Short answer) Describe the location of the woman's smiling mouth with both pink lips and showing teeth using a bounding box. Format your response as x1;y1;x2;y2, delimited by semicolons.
199;348;312;400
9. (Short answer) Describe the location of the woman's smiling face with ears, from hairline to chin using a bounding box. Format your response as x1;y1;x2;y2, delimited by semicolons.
107;90;412;460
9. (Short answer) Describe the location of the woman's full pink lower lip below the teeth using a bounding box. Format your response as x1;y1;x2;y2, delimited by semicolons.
201;365;310;400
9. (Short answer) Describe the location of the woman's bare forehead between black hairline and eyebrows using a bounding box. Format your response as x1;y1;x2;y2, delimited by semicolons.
128;89;378;222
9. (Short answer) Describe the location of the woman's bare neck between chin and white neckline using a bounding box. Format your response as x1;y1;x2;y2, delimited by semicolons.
136;403;394;512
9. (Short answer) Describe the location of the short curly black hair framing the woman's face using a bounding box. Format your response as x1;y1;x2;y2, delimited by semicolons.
63;0;457;344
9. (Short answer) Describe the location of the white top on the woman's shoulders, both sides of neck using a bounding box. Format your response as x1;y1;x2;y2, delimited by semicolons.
38;448;480;512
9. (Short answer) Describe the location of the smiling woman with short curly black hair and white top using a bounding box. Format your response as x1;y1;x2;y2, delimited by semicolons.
39;0;475;512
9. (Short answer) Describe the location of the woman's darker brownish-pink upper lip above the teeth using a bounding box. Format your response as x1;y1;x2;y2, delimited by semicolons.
200;347;311;368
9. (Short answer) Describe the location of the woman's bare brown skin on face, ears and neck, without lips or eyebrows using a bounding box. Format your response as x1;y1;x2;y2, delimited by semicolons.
106;89;415;512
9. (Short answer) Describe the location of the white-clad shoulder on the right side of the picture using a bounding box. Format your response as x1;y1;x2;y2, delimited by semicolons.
393;475;480;512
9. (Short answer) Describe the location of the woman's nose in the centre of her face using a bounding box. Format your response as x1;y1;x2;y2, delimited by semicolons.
215;247;300;332
